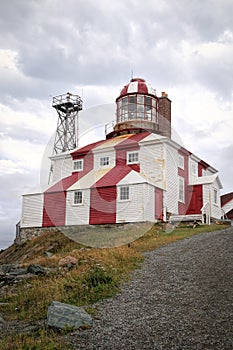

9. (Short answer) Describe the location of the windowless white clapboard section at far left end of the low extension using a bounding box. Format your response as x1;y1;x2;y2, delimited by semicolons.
20;193;44;227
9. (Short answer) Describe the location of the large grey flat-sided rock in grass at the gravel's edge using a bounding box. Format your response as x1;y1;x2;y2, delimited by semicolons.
48;301;93;330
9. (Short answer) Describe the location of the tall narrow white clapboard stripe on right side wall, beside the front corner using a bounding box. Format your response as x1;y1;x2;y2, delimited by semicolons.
164;144;179;214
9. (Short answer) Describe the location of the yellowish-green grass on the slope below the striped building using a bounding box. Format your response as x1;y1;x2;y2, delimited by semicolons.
0;225;229;350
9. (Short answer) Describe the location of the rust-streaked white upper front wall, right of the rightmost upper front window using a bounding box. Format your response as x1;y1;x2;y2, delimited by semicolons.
139;143;165;187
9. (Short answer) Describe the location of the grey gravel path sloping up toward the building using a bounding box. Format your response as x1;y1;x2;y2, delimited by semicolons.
72;228;233;350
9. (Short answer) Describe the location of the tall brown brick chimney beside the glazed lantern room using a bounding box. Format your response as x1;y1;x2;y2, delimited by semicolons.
159;91;171;138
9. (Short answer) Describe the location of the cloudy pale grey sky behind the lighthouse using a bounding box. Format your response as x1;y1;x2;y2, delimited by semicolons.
0;0;233;245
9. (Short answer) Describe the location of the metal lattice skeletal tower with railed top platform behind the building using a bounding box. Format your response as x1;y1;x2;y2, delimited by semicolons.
52;92;82;154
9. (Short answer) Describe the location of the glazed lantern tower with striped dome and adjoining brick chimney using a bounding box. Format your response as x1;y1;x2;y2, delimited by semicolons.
107;78;171;139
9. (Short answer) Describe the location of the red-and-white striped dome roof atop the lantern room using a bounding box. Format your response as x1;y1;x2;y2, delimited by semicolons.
117;78;156;99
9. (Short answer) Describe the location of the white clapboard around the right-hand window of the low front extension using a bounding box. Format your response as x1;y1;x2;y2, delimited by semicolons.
116;183;153;223
